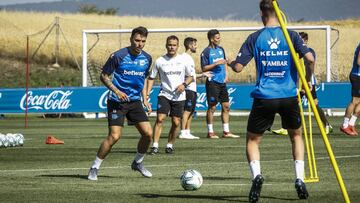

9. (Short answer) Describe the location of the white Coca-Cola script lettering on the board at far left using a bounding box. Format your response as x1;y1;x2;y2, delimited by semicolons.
20;90;73;110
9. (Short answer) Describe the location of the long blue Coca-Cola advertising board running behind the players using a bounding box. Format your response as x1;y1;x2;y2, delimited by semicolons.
0;83;351;113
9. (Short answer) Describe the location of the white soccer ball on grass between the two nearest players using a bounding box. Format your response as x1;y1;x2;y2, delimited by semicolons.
180;169;203;190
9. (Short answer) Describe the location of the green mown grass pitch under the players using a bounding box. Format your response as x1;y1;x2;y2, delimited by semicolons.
0;116;360;202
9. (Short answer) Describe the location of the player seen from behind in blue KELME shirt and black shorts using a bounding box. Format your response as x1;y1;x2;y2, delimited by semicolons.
230;0;315;202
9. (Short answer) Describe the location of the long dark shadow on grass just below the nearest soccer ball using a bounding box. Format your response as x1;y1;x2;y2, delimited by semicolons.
137;194;249;202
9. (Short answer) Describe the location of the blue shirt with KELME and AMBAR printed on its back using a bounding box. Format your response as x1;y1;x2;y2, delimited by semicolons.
236;27;309;99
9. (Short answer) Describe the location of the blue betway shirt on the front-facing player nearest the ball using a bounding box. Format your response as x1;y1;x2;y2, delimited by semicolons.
103;47;152;102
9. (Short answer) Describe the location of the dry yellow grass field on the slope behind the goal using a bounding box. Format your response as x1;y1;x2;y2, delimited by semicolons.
0;11;360;82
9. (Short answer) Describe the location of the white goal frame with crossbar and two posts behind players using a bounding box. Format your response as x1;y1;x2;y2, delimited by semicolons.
82;25;331;87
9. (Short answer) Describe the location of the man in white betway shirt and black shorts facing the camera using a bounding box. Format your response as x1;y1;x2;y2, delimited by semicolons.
147;35;195;155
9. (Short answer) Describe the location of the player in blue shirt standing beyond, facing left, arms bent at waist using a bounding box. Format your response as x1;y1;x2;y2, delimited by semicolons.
201;29;239;138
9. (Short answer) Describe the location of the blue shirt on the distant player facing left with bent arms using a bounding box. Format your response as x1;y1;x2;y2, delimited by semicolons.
201;46;226;83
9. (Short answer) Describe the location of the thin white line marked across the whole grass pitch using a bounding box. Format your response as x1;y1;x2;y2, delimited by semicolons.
0;154;360;173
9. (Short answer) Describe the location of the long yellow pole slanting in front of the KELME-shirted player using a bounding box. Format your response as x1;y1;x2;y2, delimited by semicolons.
272;0;350;203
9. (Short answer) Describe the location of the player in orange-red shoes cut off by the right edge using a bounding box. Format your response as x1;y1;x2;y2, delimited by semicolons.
340;43;360;137
